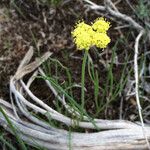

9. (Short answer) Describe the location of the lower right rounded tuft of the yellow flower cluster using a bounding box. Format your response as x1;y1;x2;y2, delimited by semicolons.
93;32;110;48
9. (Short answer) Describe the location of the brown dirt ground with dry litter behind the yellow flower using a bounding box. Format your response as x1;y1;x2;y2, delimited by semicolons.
0;0;149;123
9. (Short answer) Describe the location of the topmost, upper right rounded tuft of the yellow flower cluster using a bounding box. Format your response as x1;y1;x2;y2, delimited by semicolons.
92;17;110;33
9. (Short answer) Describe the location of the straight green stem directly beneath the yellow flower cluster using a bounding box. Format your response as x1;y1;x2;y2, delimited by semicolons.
81;50;88;109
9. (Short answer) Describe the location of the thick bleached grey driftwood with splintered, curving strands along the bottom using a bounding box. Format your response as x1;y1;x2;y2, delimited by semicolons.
0;49;150;150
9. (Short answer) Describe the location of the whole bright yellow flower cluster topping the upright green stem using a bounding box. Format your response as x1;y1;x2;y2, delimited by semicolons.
72;18;110;50
